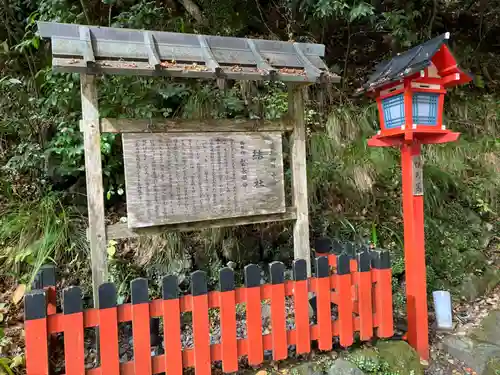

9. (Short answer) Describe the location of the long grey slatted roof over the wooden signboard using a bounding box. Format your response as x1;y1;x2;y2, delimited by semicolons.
38;22;340;83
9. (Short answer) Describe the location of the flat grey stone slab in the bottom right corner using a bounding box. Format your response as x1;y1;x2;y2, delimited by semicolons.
443;335;500;374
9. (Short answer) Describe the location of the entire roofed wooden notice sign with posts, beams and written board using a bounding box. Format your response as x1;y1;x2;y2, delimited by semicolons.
38;22;340;307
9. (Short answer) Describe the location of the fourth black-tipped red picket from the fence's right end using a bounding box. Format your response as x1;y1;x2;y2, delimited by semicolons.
315;256;332;350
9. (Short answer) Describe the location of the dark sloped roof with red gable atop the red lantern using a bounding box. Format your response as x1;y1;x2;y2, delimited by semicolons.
358;33;470;92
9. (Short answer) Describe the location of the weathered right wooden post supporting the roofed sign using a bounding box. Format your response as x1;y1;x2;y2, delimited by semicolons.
288;85;311;276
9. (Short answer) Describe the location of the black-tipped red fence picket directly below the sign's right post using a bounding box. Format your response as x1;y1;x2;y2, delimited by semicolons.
293;259;311;354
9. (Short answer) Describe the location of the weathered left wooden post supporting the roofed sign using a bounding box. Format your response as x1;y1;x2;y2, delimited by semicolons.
80;74;107;308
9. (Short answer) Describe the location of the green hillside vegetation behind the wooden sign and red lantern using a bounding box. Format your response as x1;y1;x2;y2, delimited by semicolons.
0;0;500;302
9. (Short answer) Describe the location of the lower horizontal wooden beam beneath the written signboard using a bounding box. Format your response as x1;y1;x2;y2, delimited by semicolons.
106;207;297;240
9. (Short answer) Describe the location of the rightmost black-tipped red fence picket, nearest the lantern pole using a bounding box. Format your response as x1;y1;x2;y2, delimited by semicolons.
374;251;394;338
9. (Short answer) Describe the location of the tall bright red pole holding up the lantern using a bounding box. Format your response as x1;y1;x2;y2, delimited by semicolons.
401;143;429;359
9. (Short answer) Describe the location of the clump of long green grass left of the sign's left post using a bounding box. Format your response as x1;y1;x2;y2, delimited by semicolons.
0;193;88;284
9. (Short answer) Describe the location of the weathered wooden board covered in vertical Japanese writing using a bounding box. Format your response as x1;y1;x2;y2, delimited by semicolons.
122;132;285;228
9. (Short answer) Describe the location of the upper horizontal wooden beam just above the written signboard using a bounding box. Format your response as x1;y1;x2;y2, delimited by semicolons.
95;118;293;133
